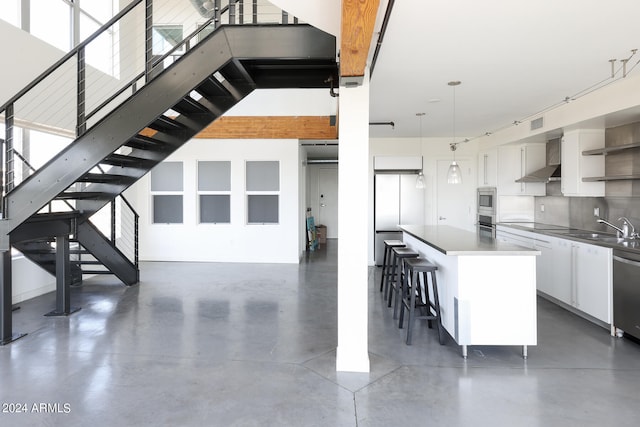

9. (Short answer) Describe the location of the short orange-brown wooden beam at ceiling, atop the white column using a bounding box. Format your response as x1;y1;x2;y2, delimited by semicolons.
340;0;380;77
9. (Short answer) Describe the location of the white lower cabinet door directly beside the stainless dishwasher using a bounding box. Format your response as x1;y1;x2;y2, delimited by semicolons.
573;243;611;324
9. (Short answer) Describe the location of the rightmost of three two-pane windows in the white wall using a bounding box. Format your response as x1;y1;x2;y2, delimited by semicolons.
246;161;280;224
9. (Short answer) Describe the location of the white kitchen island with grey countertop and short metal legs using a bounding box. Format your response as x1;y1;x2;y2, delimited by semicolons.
400;225;540;358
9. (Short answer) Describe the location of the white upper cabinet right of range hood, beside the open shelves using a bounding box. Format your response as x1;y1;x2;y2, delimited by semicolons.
561;129;605;197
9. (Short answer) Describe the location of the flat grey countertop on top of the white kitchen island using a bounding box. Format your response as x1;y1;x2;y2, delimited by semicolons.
400;225;540;255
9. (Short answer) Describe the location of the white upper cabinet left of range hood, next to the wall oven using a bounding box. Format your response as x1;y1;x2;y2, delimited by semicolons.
498;144;546;196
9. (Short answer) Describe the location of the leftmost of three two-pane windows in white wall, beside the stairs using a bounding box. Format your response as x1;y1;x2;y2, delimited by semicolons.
151;162;184;224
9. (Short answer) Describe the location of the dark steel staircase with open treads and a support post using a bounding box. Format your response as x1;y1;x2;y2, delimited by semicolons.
0;0;337;343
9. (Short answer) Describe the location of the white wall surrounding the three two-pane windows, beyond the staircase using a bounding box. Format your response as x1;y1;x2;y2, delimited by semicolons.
127;139;304;263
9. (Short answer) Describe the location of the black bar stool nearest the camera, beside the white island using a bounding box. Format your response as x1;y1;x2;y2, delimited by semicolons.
398;258;445;345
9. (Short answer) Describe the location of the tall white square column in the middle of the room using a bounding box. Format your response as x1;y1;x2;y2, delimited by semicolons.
336;69;369;372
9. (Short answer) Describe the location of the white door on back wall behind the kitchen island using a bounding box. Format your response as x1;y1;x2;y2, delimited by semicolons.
436;160;476;231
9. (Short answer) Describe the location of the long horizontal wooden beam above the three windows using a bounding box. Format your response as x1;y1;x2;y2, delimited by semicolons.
195;116;338;139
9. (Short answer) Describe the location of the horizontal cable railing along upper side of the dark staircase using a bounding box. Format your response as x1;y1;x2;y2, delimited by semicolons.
0;0;298;216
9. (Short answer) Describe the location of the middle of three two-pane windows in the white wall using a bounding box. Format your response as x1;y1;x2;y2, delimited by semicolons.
198;161;231;224
